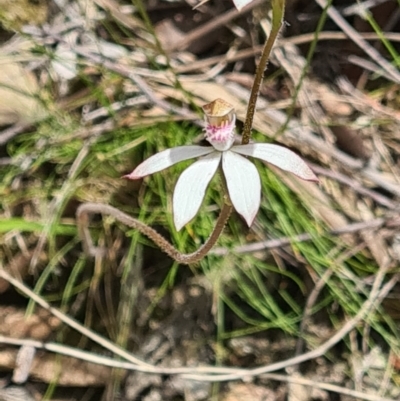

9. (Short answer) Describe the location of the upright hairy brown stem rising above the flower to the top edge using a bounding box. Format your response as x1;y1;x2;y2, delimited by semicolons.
242;0;285;145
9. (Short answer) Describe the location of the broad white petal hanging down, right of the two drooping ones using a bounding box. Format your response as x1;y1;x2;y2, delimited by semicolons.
222;151;261;227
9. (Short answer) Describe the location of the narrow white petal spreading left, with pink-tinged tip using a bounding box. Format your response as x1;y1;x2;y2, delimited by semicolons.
124;145;214;180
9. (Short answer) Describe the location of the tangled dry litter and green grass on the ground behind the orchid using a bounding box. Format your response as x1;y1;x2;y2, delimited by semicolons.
0;0;400;400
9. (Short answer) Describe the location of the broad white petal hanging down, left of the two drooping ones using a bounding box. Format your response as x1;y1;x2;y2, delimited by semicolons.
172;151;221;231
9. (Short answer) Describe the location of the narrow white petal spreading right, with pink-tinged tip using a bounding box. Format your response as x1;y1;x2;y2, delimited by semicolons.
231;143;318;181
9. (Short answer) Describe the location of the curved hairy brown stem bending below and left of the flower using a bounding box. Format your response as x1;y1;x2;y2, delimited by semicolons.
76;202;232;265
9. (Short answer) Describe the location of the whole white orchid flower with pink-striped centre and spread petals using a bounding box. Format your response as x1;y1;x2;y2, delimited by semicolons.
125;99;318;231
